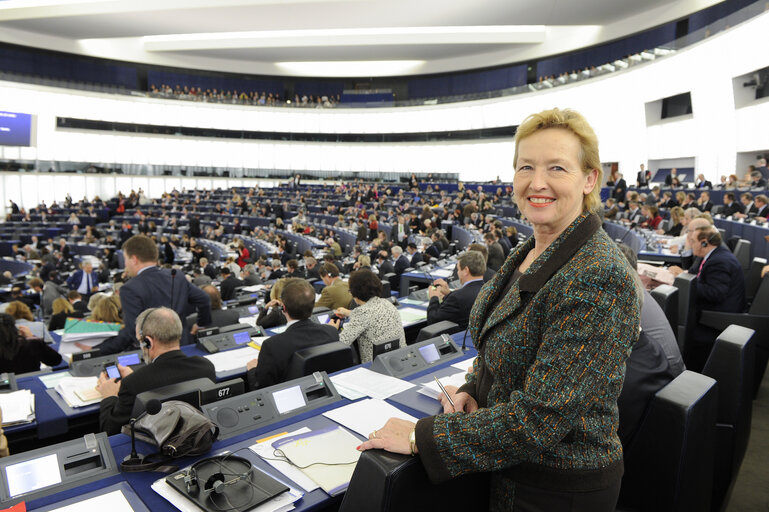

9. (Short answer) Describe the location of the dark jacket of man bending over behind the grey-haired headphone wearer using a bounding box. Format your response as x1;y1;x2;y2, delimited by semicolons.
94;267;211;355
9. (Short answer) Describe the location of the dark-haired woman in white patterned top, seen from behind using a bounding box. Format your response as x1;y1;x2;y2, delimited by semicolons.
329;269;406;363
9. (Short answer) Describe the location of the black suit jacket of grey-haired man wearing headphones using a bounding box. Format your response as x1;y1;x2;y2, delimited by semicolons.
99;352;216;435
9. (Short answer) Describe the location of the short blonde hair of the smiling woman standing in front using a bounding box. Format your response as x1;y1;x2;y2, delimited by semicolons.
513;108;603;213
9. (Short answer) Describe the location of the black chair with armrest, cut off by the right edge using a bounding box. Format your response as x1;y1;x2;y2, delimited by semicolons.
700;275;769;398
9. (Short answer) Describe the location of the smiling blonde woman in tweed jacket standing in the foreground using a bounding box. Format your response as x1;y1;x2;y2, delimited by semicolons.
361;109;640;512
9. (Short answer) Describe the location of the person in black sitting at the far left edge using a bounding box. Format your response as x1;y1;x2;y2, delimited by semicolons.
0;313;61;374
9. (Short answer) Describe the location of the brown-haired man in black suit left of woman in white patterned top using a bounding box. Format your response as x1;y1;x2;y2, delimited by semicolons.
246;281;339;389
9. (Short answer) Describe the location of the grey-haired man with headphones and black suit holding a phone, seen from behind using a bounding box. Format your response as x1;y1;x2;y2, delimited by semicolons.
96;306;216;435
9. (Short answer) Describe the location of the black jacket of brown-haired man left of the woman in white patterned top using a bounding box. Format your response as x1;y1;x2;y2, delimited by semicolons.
247;319;339;389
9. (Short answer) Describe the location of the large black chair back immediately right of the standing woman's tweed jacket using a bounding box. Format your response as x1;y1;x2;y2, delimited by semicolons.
617;370;718;512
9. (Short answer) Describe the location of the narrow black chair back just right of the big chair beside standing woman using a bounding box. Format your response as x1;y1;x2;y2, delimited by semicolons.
702;325;755;511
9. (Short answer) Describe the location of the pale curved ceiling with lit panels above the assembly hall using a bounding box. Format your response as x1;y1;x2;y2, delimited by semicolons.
0;0;718;76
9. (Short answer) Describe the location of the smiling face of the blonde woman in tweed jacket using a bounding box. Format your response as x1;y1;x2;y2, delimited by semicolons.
513;128;598;235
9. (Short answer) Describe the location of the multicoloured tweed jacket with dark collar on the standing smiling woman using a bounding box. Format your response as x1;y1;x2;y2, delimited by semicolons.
416;214;641;510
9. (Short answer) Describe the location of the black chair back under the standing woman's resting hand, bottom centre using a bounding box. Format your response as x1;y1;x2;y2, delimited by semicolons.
339;450;489;512
